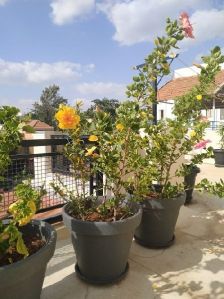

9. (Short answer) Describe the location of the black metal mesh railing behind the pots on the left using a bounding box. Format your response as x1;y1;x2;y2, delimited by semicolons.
0;136;102;218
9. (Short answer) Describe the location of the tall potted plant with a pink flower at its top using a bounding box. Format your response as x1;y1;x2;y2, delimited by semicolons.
122;13;224;248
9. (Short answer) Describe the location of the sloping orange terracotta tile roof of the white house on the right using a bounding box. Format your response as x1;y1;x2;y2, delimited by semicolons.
158;70;224;101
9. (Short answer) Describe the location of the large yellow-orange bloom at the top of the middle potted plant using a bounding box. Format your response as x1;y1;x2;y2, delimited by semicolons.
55;106;80;129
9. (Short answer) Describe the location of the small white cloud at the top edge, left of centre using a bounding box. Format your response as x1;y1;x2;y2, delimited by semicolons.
50;0;95;25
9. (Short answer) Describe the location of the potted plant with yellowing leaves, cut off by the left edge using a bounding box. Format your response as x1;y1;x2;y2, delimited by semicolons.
0;106;56;299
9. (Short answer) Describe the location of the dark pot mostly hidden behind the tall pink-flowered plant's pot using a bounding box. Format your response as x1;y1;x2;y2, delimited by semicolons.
184;165;200;205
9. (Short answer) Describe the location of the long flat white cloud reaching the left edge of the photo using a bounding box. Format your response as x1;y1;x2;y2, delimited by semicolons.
0;59;94;84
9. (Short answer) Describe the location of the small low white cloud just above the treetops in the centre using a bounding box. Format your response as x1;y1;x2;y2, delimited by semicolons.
74;82;126;100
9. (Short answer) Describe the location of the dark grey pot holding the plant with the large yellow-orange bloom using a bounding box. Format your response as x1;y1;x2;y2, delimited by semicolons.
62;204;142;284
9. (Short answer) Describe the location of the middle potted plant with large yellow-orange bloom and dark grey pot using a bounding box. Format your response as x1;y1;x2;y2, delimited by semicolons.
52;102;142;284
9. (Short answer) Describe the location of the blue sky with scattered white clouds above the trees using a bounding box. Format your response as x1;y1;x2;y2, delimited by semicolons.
0;0;224;112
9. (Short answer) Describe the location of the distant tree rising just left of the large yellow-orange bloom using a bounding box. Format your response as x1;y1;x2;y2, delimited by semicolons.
31;85;68;128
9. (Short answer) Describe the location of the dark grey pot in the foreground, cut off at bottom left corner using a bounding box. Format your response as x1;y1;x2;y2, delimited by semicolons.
0;220;56;299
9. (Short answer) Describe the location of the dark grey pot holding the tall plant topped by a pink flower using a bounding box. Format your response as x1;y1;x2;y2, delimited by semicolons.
135;193;185;248
